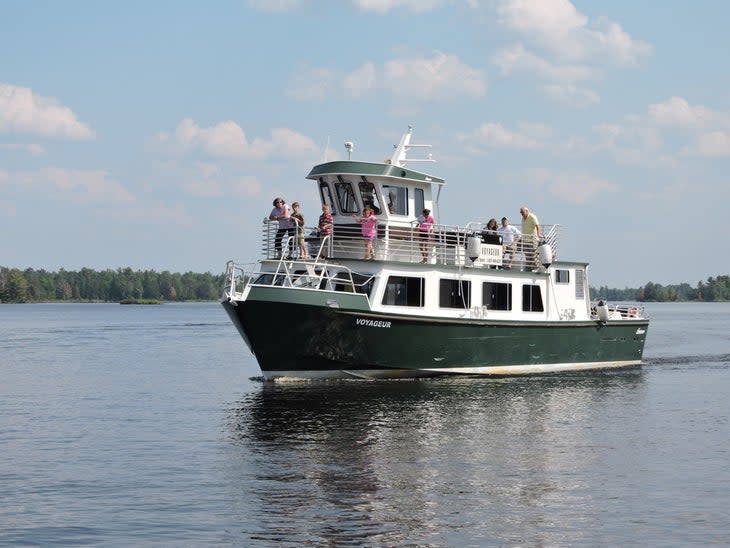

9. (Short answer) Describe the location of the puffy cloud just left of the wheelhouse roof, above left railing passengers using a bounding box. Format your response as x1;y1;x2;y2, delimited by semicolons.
157;118;318;160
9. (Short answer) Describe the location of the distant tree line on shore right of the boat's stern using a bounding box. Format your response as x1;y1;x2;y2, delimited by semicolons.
591;276;730;302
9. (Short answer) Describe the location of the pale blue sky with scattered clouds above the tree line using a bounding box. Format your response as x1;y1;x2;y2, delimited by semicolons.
0;0;730;288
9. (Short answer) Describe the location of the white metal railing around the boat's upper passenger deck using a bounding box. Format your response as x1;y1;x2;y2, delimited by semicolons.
261;219;560;270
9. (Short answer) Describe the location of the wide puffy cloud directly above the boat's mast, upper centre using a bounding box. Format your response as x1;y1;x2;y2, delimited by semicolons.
288;51;487;101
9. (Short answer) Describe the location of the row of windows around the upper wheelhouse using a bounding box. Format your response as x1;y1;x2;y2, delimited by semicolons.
319;175;425;215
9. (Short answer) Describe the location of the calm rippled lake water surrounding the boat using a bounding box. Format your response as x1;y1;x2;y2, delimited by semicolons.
0;303;730;546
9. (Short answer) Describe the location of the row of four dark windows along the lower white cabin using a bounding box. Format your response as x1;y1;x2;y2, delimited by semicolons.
383;276;544;312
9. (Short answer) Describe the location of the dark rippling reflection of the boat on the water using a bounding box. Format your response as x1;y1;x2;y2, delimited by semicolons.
229;369;644;545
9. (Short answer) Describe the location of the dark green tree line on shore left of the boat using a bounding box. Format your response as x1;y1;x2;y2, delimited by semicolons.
0;266;225;303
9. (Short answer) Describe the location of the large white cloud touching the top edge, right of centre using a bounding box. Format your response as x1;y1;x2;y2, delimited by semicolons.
497;0;652;65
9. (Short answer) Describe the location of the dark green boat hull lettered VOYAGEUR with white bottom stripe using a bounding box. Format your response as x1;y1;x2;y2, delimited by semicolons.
223;288;648;378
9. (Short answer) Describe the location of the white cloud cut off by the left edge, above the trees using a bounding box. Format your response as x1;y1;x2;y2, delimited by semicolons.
0;83;94;140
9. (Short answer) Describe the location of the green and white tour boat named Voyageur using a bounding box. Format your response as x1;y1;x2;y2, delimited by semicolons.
221;128;649;380
